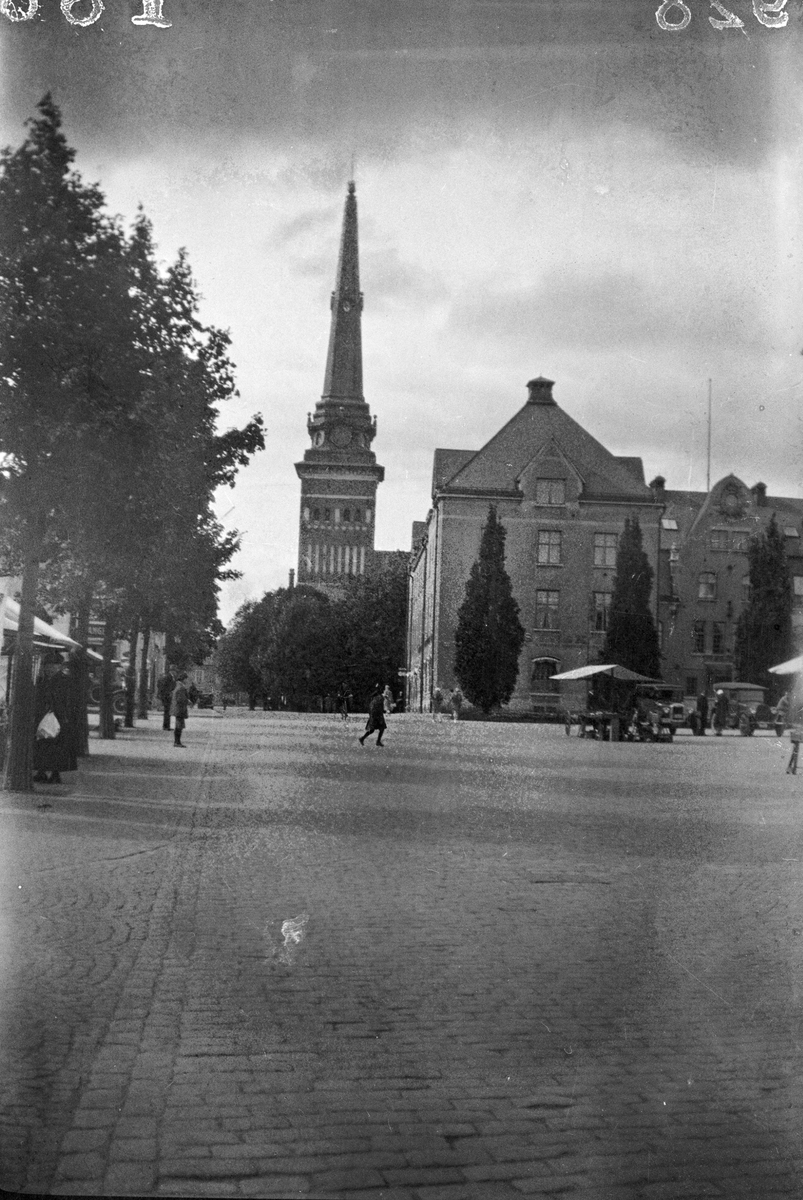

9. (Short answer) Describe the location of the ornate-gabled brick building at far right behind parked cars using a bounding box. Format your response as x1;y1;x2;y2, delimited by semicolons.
652;475;803;696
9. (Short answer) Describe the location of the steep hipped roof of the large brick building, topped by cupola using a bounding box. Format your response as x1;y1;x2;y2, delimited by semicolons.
436;377;654;503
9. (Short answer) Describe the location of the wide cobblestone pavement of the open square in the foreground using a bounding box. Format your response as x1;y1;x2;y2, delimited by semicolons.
0;710;803;1200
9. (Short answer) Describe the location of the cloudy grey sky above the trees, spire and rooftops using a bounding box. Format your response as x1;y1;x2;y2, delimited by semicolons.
0;0;803;622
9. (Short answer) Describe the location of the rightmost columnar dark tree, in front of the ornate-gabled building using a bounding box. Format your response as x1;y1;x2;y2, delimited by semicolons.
735;512;792;686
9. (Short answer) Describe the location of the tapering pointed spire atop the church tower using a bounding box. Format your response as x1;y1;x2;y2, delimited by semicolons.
323;180;362;400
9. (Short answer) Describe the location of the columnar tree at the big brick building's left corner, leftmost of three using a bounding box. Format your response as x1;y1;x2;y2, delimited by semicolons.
455;505;525;713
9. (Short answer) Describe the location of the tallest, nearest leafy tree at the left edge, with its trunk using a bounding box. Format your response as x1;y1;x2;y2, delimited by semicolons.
0;96;152;791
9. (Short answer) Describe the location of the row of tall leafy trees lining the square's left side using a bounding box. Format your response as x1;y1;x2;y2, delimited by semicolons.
0;95;264;791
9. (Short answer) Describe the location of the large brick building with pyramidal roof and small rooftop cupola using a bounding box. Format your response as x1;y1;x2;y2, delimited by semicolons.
407;378;664;712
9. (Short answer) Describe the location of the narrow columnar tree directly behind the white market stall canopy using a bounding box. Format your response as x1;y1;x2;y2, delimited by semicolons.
601;517;660;679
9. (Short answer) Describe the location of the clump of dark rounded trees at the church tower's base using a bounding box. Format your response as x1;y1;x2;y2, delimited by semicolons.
216;553;408;712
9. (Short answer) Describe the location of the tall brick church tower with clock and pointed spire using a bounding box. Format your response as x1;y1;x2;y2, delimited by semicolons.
295;182;385;595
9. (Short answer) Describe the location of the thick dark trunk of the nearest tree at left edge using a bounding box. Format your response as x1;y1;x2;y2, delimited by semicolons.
4;528;43;792
